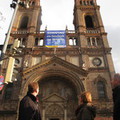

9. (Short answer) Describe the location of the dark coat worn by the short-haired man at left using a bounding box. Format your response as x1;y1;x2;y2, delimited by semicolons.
18;93;41;120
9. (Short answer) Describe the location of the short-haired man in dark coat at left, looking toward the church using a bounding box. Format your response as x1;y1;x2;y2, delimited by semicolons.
18;82;41;120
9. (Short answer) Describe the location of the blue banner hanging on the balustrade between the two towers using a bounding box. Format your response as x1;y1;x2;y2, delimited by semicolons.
45;30;66;48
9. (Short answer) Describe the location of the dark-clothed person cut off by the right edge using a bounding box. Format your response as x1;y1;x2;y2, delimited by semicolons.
112;74;120;120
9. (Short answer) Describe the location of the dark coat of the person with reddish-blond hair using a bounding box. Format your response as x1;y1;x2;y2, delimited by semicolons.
75;103;96;120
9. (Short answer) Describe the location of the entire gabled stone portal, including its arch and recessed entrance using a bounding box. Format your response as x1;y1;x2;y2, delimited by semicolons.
20;57;87;120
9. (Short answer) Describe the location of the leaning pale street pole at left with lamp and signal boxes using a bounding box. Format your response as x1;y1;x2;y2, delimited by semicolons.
0;0;29;88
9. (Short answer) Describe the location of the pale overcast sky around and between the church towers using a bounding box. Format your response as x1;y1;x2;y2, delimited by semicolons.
0;0;120;73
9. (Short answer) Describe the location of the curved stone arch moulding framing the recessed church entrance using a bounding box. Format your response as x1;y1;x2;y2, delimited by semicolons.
20;69;85;96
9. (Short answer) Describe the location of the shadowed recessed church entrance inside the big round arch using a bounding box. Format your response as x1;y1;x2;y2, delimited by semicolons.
39;75;78;120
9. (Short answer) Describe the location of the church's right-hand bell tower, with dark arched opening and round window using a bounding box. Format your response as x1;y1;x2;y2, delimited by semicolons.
73;0;114;115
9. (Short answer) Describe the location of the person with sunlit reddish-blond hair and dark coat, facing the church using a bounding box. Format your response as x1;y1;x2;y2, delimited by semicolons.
75;92;96;120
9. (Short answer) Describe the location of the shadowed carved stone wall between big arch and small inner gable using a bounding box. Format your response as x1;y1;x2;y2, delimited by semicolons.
40;77;76;101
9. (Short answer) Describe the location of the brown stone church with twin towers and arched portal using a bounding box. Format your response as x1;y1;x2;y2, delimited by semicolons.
0;0;114;120
